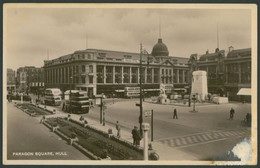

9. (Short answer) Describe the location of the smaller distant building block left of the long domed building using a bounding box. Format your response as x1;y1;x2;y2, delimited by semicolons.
17;66;45;93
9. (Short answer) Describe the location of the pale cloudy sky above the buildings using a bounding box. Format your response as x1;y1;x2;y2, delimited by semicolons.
4;5;251;70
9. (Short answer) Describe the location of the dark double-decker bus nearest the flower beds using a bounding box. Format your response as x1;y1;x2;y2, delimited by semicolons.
63;90;90;114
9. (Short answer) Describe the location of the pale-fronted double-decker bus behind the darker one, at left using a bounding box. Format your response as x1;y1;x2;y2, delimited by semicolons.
44;88;62;106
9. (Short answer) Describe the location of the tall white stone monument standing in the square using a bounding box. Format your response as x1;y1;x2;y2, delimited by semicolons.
191;71;208;100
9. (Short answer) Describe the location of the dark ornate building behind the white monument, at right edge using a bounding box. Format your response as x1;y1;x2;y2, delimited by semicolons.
188;47;251;101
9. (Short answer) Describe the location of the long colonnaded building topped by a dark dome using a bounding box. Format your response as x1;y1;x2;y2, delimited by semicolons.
44;39;190;96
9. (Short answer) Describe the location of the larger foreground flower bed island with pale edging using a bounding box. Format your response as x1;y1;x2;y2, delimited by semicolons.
44;117;143;160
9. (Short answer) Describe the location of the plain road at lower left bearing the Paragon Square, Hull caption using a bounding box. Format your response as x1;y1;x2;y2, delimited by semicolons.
7;103;89;160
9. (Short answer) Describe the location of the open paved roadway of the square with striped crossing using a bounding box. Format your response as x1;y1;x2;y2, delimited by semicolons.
30;96;251;160
